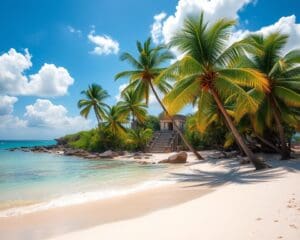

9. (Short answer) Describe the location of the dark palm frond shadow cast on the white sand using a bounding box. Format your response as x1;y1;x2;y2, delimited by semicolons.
171;158;300;187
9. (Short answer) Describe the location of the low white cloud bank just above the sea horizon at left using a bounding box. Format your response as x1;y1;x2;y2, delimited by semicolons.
0;99;93;139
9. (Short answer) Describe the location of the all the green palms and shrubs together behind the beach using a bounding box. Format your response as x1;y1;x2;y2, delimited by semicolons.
65;11;300;169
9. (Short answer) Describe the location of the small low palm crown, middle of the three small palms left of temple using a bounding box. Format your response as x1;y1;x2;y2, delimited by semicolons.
103;105;127;136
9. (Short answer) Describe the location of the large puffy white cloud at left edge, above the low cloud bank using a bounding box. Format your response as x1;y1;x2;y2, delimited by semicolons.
0;48;74;97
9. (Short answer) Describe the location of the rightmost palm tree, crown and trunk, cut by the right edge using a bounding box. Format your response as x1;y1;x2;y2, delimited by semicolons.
244;32;300;159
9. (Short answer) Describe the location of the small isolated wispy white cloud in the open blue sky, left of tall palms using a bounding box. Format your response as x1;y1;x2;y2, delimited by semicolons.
88;30;120;55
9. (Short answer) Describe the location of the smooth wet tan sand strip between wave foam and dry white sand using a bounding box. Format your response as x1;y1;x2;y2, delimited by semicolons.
0;183;213;240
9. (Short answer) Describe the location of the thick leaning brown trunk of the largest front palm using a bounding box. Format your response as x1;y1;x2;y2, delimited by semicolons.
211;89;269;170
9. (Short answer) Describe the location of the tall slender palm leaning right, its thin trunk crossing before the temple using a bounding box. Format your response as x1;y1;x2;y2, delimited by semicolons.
115;38;202;159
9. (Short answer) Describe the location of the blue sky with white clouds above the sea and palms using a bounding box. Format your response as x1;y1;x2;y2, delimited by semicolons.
0;0;300;139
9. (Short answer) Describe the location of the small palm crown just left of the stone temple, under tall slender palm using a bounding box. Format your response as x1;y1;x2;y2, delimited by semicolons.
118;89;147;124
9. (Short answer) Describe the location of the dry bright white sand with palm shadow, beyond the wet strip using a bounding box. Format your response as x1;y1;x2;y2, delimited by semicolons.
48;154;300;240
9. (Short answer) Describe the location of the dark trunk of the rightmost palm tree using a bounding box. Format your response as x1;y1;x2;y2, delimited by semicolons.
270;97;291;160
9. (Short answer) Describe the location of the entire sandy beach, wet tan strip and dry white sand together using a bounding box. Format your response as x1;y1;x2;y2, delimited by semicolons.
0;152;300;240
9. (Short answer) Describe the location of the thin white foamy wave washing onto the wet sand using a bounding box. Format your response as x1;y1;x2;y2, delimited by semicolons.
0;180;176;218
